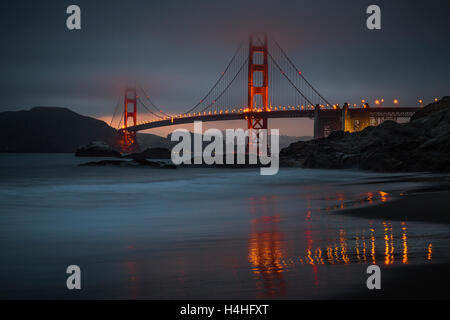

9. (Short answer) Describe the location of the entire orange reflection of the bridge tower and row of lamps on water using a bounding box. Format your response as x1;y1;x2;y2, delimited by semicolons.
248;191;433;298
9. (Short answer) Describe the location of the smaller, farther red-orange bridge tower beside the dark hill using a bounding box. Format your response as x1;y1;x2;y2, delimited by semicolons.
117;88;139;153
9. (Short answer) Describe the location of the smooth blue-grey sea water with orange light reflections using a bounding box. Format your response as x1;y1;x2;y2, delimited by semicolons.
0;154;450;299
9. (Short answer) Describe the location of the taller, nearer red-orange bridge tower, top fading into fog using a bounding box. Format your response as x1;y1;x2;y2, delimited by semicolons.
247;34;269;148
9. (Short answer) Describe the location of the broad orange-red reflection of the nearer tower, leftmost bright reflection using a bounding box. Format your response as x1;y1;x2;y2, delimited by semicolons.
248;197;286;298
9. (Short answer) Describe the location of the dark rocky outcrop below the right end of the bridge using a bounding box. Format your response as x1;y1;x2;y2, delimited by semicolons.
280;97;450;172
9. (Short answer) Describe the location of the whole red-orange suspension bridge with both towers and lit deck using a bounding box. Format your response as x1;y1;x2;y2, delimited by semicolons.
111;34;420;152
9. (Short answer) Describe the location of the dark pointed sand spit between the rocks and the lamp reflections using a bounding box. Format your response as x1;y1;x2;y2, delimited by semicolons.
341;190;450;224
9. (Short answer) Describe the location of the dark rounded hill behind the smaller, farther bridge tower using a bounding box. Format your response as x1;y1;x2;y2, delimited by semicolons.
0;107;166;153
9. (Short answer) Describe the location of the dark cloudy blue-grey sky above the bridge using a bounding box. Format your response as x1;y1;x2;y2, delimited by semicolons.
0;0;450;133
